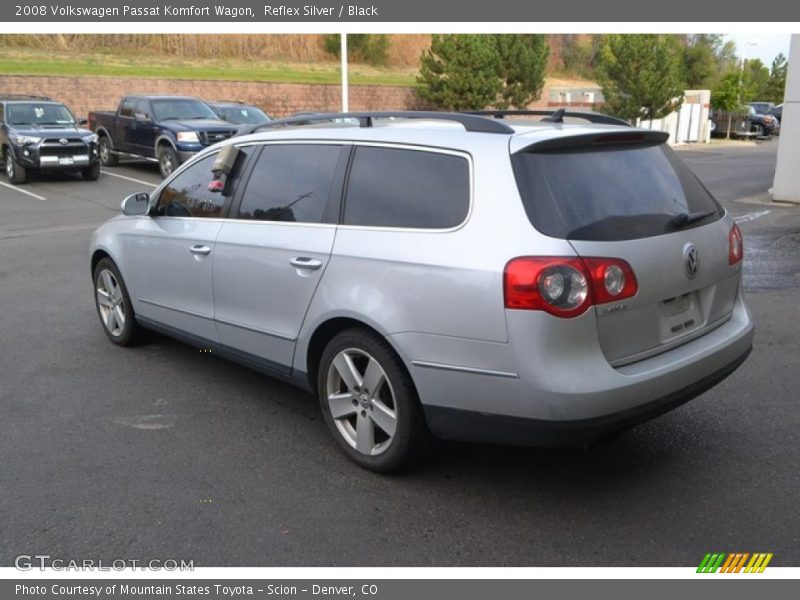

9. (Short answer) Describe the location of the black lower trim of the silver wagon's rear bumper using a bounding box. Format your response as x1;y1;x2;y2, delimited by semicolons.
424;347;752;447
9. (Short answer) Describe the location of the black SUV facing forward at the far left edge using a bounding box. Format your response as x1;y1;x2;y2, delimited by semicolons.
0;95;100;184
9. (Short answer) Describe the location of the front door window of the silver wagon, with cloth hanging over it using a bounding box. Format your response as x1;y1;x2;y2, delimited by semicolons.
156;147;247;219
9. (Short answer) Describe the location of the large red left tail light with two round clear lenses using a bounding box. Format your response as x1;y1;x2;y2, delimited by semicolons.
503;256;639;318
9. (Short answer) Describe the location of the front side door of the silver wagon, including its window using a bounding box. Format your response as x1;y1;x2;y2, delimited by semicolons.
125;153;246;342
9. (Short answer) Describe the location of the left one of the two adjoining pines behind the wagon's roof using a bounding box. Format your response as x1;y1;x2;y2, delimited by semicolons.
417;34;501;110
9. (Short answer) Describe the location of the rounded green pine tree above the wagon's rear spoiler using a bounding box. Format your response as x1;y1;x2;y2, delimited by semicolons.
597;34;685;122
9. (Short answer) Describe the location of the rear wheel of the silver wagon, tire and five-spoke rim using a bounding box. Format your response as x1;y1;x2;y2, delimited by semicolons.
317;329;430;473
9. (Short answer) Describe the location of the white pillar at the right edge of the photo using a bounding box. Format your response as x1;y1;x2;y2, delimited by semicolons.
772;33;800;202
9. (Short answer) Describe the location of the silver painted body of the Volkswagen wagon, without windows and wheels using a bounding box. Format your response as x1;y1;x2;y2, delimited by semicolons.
91;122;753;445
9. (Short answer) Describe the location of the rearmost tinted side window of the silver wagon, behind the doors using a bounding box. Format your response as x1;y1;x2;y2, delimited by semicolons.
344;146;470;229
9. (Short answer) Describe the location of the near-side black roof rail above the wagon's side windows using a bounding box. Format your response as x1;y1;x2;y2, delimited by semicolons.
242;111;514;134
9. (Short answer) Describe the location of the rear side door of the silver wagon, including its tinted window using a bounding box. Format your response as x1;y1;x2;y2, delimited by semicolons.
213;143;347;373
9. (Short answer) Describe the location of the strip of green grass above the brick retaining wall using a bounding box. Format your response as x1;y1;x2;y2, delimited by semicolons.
0;48;416;86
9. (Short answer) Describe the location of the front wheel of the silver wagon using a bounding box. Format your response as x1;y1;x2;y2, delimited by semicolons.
92;258;142;346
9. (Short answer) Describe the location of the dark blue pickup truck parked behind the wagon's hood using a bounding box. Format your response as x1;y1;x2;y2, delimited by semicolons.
89;96;236;177
